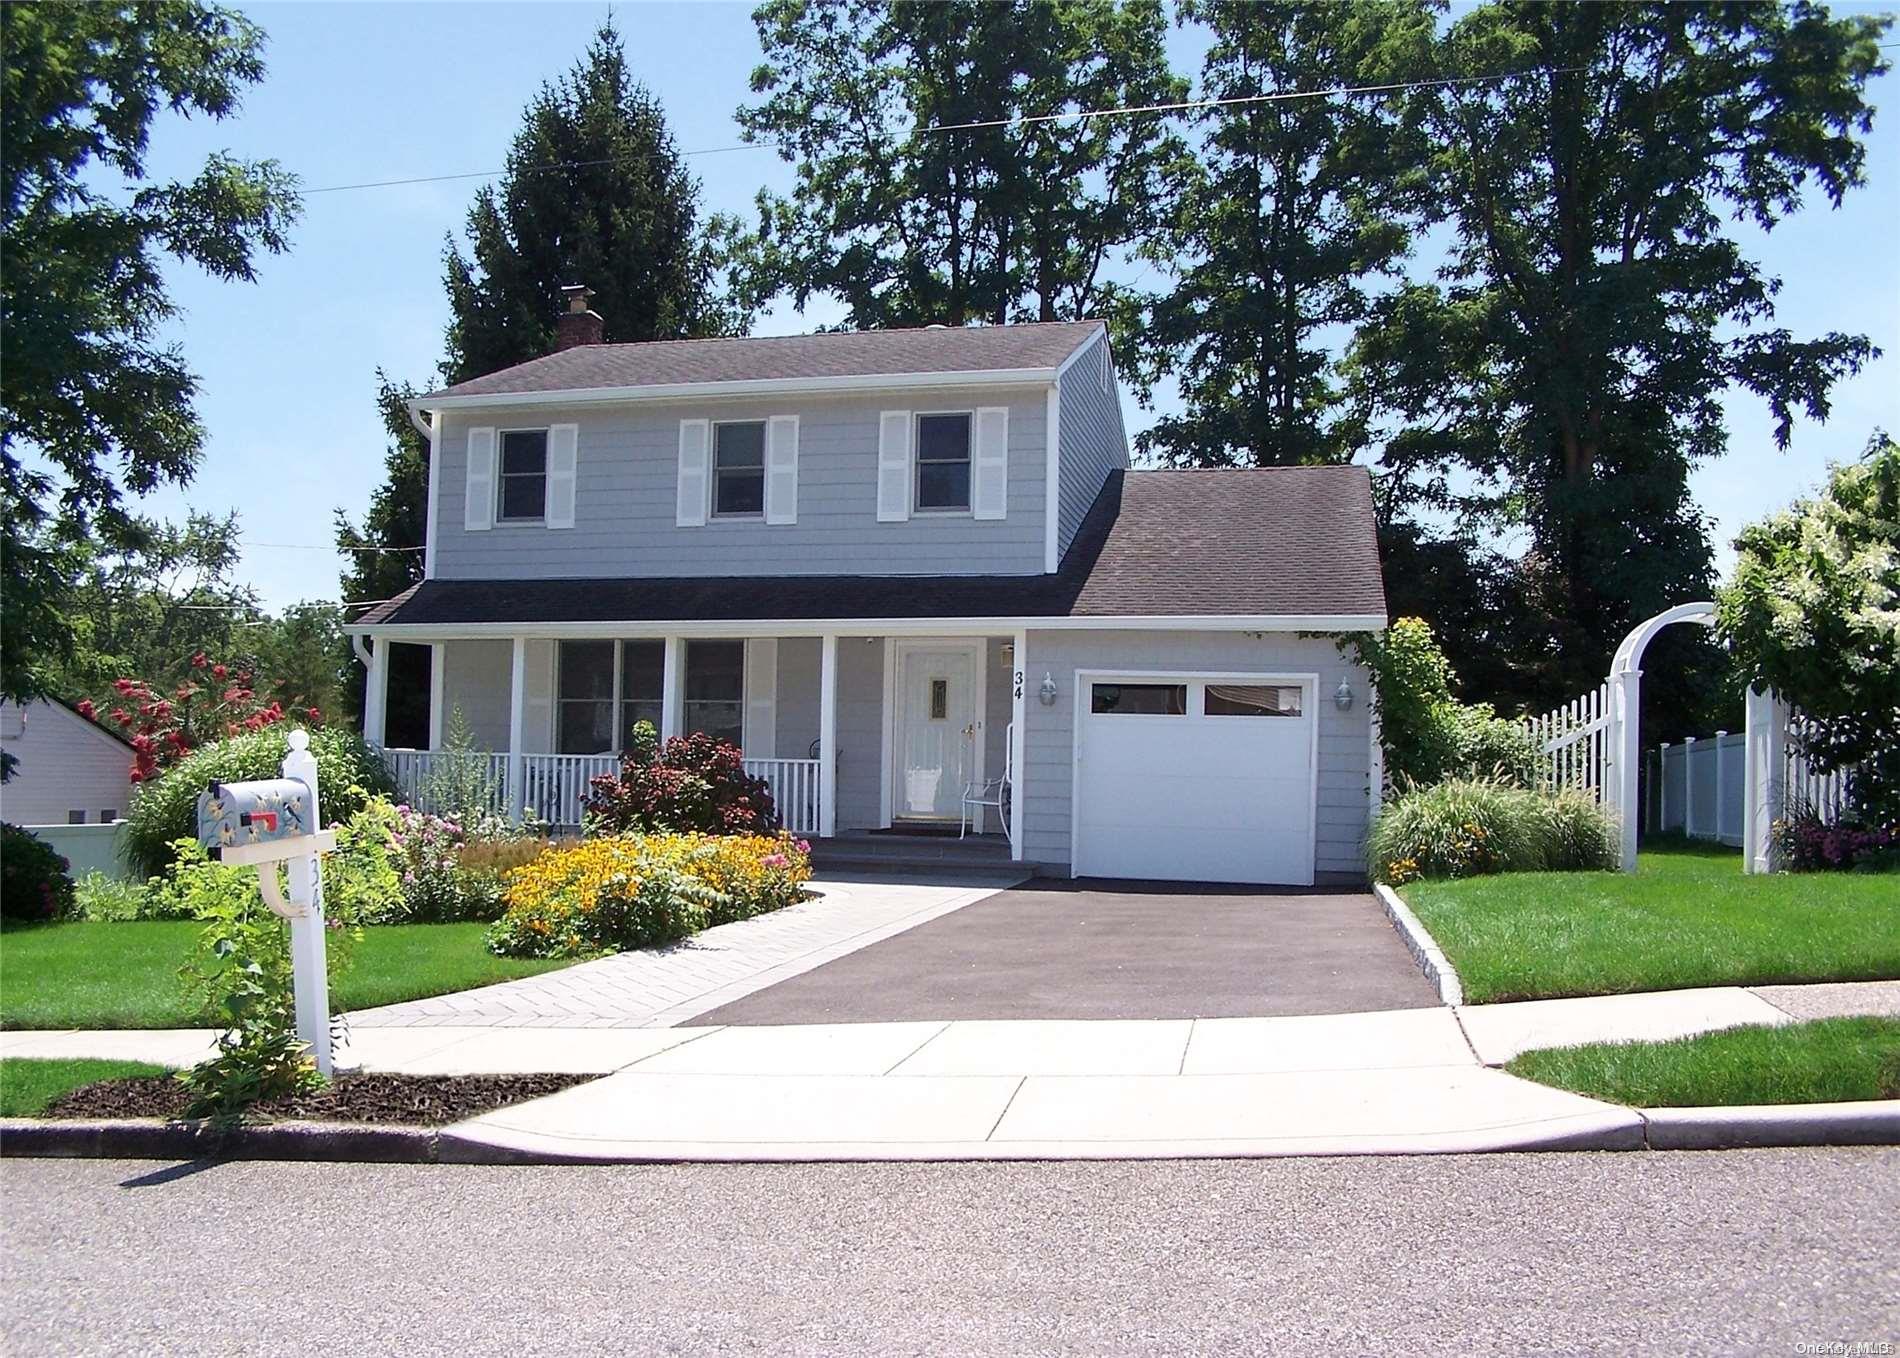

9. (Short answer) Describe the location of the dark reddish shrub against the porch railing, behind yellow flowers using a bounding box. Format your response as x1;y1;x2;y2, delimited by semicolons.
585;722;779;834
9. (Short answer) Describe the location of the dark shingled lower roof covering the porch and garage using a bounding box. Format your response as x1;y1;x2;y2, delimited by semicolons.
352;467;1385;629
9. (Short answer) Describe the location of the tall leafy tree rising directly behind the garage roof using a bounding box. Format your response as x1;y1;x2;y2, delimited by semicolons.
1123;0;1433;467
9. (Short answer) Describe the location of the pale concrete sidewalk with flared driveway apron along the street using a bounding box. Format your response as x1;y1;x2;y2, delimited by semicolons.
0;982;1900;1160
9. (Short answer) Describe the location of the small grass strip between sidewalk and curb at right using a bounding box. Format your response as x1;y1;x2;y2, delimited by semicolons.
1505;1018;1900;1107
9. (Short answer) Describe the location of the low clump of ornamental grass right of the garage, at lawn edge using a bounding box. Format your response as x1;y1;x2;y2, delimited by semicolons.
1366;779;1617;885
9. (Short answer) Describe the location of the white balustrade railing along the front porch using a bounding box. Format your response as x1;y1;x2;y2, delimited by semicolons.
382;750;819;836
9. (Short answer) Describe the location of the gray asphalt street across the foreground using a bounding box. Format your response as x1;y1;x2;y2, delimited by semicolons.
0;1149;1900;1358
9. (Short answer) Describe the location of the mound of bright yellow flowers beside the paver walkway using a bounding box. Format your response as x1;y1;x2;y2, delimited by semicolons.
488;834;811;957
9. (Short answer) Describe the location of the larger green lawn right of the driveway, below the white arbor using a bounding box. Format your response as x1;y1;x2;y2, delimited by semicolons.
1400;843;1900;1005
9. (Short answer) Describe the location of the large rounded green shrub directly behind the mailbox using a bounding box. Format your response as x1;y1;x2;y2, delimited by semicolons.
125;726;395;876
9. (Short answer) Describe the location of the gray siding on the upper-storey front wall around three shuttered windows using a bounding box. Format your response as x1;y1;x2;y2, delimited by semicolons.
435;387;1049;579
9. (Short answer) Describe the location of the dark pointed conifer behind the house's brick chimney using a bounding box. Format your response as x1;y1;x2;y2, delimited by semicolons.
443;25;751;382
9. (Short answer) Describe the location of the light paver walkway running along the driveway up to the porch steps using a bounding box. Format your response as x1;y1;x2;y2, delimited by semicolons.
350;870;1022;1028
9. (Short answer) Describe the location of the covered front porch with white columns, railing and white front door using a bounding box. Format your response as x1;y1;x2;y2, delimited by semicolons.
363;627;1022;858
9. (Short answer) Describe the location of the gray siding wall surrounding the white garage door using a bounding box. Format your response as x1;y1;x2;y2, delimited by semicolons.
1022;632;1372;876
